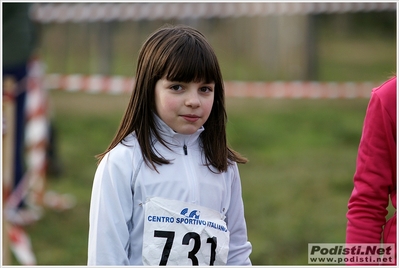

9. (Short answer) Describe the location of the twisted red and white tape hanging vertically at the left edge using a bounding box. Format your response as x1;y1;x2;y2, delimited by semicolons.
3;59;48;265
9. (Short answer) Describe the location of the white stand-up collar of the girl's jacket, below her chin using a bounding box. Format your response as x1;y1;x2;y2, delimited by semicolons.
154;114;205;150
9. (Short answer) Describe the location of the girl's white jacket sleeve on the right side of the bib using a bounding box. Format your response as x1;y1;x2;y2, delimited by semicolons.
226;163;252;266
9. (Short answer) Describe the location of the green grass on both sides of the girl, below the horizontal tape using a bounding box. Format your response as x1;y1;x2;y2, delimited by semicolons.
14;91;396;265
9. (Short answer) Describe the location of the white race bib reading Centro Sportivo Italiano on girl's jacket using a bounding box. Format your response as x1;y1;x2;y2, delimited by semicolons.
143;197;230;266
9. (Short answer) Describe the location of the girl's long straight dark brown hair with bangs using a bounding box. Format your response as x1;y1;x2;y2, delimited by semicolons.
96;25;247;172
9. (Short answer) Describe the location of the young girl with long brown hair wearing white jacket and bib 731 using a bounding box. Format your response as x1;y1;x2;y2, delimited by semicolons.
88;26;252;265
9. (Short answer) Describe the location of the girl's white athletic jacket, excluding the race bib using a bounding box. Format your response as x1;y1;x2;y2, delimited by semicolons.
88;118;252;265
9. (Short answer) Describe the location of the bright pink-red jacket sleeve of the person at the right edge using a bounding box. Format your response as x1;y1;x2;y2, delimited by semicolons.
346;85;396;243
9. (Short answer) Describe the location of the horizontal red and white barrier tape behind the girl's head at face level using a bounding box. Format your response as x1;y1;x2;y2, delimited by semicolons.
45;74;380;99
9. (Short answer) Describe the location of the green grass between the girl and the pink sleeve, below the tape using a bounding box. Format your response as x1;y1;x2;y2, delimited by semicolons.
229;100;367;265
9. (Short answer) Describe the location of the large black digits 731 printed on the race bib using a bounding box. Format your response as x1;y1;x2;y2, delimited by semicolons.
154;230;217;266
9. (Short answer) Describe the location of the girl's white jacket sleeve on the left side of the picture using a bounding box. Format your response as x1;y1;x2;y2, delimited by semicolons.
88;147;133;265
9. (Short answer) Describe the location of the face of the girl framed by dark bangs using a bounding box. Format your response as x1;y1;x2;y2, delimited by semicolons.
155;77;215;135
